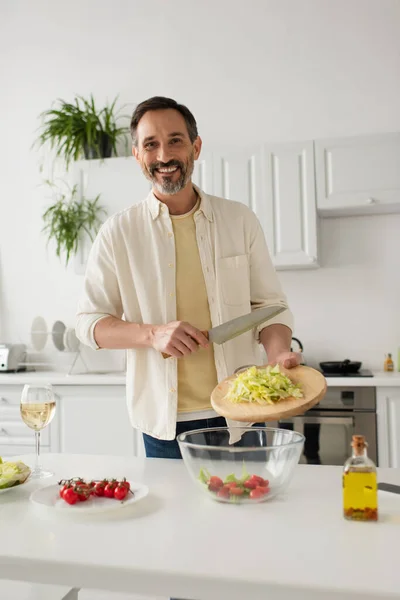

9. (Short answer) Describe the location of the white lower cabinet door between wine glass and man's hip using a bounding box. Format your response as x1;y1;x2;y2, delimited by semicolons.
56;385;137;456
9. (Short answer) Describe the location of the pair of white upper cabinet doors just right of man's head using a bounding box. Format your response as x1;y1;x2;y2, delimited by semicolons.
213;141;318;269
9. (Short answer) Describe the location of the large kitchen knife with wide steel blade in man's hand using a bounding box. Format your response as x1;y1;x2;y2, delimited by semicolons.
162;304;286;358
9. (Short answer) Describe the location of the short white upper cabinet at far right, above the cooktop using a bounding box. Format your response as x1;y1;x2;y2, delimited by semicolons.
315;133;400;217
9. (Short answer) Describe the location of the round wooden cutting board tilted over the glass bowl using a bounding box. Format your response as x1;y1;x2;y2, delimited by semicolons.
211;366;327;423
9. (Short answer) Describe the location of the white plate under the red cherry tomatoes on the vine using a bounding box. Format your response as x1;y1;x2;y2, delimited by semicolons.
30;482;149;515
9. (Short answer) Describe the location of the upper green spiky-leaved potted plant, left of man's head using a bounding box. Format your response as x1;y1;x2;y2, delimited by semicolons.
36;95;128;169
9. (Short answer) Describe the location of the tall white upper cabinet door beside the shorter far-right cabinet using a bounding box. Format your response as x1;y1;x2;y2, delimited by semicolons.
264;142;318;269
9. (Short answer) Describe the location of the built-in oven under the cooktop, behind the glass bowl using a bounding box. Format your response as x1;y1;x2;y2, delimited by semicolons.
277;386;378;465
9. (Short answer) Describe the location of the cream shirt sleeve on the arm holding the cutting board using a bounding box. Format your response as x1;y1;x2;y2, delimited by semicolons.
245;212;293;341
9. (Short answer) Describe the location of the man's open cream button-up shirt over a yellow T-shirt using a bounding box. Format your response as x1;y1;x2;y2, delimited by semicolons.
76;188;293;440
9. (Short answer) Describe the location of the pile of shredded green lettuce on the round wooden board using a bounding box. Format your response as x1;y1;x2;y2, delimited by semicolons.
226;365;303;404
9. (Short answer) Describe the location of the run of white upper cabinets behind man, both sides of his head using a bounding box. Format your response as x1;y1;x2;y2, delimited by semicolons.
72;147;318;274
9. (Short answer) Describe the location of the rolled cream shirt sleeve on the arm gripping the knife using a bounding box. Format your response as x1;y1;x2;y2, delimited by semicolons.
75;225;123;350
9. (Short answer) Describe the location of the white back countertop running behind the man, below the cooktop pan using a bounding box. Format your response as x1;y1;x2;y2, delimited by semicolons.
0;371;400;387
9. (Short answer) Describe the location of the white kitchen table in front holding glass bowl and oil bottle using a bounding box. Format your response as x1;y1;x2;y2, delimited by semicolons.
0;454;400;600
